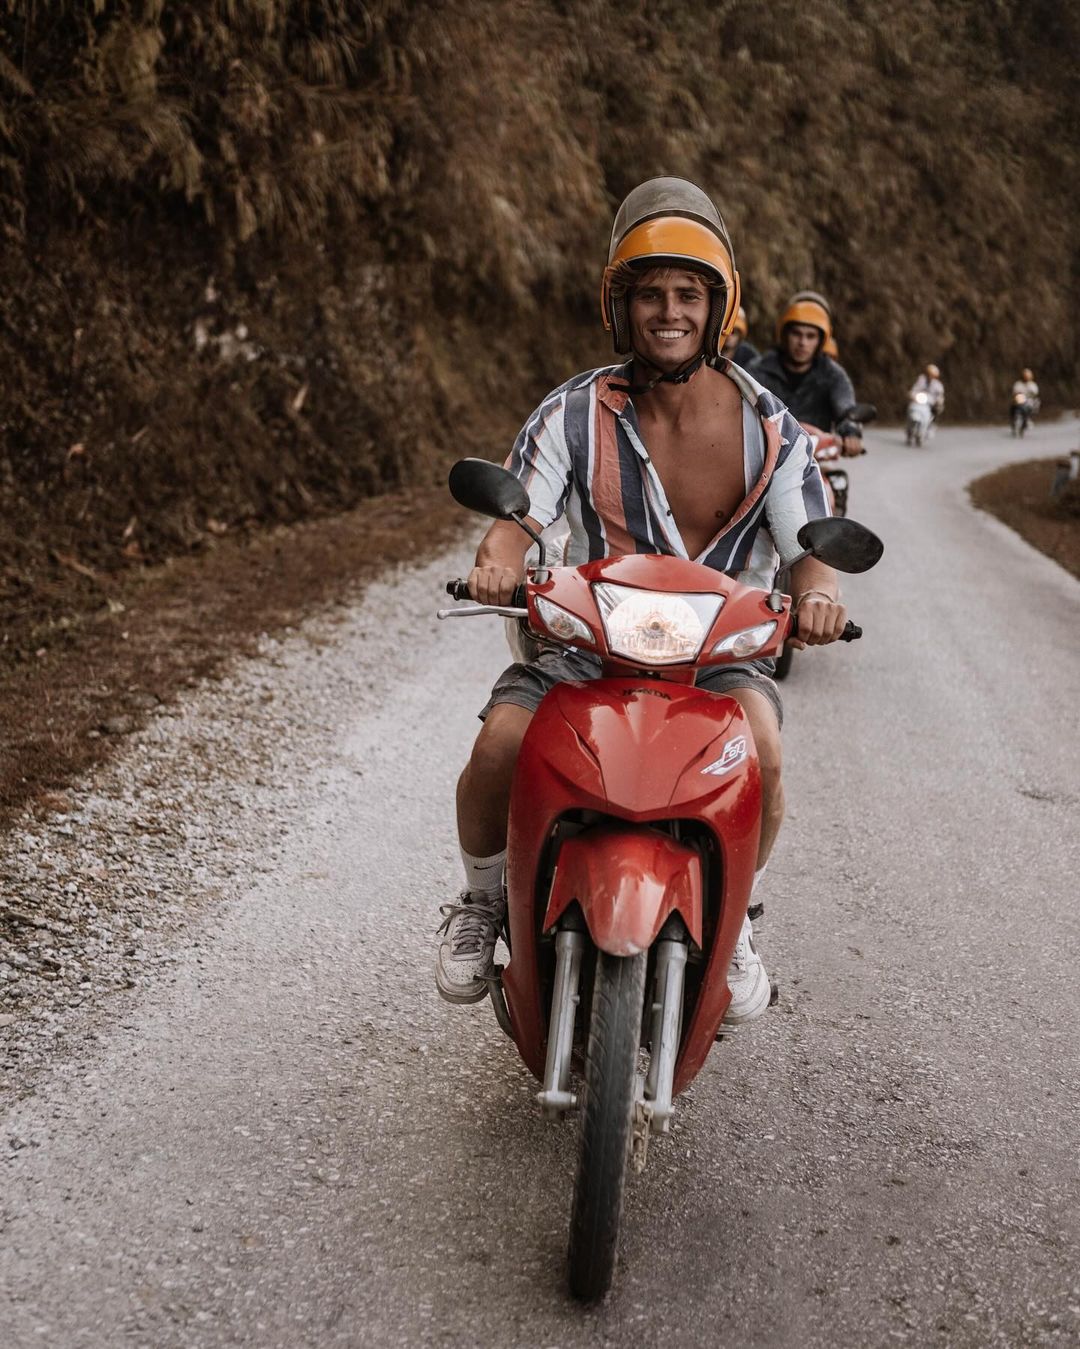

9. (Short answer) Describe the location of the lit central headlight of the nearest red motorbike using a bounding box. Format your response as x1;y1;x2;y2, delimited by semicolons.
593;581;724;665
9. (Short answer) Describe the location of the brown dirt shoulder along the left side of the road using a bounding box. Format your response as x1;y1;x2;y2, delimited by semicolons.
0;487;465;828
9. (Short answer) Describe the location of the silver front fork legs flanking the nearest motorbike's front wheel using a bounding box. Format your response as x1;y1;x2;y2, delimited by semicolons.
537;915;688;1168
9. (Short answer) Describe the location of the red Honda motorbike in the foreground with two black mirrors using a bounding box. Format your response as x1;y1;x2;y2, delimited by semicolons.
438;459;882;1299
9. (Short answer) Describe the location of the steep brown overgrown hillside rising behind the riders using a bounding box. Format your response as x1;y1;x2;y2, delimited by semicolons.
0;0;1080;614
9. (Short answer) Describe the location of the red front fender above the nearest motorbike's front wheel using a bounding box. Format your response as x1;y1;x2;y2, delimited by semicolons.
543;822;702;955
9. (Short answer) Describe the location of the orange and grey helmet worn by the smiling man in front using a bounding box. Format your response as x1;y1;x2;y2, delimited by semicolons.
600;178;739;357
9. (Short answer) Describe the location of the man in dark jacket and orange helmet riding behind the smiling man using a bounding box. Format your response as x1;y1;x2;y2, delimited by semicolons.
750;290;863;455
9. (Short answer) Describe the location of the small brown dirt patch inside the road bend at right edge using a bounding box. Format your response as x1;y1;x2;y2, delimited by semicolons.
969;459;1080;577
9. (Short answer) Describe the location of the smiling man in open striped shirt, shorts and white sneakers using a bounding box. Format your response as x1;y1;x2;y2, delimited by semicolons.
436;178;847;1025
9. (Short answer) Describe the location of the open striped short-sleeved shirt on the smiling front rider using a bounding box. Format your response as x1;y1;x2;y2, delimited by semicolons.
506;357;829;590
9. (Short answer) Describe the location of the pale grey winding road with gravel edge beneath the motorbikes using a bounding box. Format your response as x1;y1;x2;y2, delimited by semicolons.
0;422;1080;1349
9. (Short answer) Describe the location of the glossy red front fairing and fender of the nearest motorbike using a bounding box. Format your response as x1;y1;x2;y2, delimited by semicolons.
503;676;760;1090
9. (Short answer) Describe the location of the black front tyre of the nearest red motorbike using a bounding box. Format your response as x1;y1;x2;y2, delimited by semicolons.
569;951;647;1300
